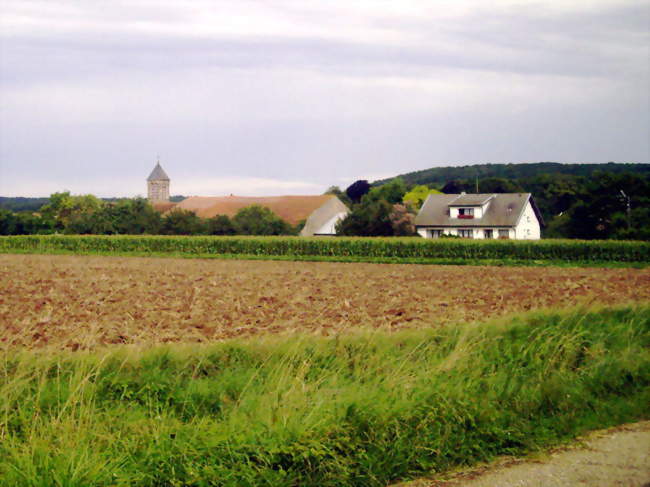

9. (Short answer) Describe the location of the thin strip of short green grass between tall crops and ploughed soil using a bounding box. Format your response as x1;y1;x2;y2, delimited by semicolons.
0;249;650;269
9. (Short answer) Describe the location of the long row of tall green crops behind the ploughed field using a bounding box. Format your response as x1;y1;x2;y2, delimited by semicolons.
0;235;650;262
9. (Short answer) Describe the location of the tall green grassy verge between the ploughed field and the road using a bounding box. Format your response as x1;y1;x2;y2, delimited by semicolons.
0;305;650;487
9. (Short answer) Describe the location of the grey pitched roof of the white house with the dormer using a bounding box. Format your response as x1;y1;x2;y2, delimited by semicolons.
415;193;544;227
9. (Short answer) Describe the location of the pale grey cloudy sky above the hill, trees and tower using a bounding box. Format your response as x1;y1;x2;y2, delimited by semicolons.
0;0;650;197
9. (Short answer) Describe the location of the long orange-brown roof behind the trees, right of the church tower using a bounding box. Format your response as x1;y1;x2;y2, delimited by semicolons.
170;194;336;225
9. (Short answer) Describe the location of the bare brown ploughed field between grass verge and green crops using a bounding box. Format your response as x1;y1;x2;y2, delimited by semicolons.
0;255;650;350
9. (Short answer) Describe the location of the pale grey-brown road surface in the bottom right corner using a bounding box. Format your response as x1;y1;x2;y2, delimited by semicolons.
394;421;650;487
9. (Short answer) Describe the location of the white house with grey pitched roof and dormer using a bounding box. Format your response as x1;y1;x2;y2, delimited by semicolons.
415;193;544;240
